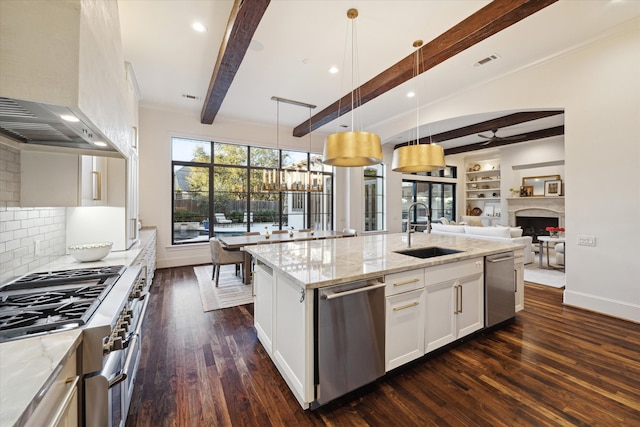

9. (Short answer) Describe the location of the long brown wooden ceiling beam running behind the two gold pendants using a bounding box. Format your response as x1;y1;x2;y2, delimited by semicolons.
293;0;558;137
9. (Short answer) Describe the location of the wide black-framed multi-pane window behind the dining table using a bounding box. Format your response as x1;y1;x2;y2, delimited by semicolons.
172;138;333;244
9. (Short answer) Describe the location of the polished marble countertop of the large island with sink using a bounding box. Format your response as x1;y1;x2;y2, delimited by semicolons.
244;233;524;289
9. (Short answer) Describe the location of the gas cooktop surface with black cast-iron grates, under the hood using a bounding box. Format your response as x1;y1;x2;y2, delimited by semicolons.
0;266;124;341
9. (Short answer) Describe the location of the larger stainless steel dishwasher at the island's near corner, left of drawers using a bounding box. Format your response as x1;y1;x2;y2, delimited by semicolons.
311;278;385;408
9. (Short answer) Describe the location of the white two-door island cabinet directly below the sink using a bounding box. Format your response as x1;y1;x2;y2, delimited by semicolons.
425;258;484;353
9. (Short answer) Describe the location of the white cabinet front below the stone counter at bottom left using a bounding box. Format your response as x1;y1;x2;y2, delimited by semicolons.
25;352;80;427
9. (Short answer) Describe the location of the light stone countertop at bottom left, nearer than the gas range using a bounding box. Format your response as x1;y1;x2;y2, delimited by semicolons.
0;329;82;427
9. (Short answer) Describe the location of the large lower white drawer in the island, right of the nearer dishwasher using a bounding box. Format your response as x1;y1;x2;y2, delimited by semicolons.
385;288;425;371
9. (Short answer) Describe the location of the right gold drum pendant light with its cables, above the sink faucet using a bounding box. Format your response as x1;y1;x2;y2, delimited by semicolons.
391;40;445;173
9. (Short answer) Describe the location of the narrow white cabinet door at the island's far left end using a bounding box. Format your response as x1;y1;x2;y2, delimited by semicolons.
253;261;274;356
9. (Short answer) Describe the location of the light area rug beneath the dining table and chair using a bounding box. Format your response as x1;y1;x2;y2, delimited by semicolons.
193;265;253;311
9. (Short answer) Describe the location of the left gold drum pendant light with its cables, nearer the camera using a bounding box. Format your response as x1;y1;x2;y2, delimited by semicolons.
323;9;382;167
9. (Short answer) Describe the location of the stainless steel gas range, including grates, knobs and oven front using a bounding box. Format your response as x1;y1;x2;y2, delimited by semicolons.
0;265;150;427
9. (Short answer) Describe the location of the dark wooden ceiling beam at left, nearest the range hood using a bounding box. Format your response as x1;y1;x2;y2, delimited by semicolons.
200;0;271;125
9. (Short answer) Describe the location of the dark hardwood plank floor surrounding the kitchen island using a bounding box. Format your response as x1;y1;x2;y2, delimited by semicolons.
126;267;640;427
